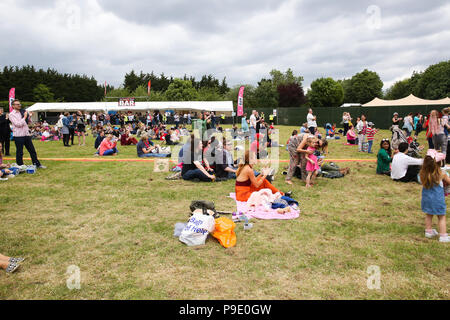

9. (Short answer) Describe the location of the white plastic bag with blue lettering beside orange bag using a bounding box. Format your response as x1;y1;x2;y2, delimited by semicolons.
179;213;216;246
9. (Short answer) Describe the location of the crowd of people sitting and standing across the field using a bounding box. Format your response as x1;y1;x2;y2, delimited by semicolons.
0;104;450;272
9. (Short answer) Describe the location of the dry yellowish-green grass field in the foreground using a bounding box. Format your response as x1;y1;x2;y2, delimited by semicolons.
0;127;450;299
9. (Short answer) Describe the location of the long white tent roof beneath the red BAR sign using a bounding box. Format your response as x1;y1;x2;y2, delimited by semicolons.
27;101;233;112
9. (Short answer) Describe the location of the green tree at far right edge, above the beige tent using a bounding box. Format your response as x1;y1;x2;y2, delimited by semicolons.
415;60;450;100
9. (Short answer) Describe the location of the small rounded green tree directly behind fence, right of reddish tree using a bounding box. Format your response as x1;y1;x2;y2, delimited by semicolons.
307;78;344;108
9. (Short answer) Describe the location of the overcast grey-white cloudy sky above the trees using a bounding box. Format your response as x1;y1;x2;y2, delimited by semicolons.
0;0;450;89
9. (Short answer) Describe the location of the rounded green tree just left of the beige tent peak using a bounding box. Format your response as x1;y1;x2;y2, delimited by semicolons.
345;69;383;104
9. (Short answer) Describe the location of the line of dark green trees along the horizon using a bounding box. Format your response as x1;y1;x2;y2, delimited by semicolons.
0;60;450;109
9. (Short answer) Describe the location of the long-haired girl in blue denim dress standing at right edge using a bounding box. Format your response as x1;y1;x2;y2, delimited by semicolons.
420;153;450;242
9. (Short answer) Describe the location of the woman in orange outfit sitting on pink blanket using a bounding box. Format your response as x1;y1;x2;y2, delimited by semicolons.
236;150;284;201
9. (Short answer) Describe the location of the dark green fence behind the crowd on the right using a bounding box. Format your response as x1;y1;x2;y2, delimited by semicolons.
243;106;446;129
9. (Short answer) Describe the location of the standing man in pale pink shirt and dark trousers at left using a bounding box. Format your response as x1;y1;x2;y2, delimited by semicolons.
9;100;47;169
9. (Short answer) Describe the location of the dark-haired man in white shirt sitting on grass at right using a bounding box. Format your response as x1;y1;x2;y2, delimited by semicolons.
391;142;423;182
